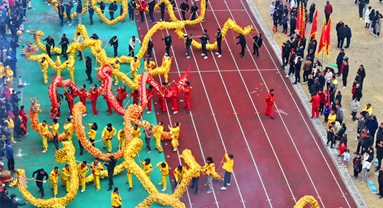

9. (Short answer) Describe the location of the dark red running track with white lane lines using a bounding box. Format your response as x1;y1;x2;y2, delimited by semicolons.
136;0;356;207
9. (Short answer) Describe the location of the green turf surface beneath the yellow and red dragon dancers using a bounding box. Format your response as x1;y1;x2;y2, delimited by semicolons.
9;1;172;208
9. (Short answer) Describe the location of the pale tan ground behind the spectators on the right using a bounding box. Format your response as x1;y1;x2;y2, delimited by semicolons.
253;0;383;207
